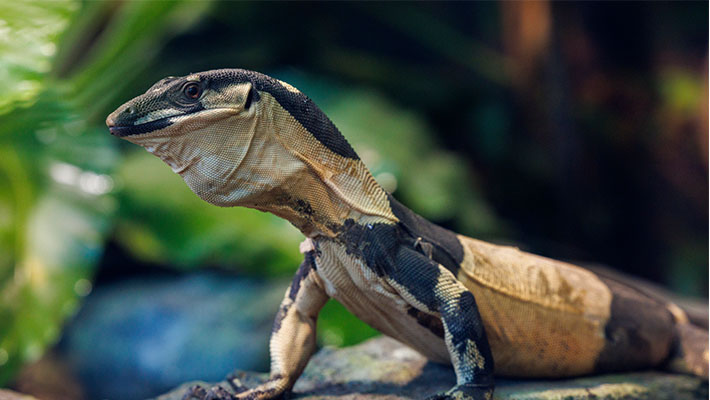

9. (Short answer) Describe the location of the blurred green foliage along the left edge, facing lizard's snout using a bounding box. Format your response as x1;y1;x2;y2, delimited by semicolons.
0;1;217;384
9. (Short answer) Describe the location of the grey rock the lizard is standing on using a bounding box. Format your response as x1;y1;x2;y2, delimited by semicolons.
157;337;708;400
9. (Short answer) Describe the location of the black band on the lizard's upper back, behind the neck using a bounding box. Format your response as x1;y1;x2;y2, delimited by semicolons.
387;194;464;276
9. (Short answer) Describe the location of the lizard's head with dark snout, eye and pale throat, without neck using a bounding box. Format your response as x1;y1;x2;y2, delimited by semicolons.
106;71;266;196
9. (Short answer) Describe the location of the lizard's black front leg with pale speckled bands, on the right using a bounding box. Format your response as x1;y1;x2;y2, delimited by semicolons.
389;247;494;400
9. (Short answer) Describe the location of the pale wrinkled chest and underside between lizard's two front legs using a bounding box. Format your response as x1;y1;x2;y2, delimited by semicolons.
316;241;450;363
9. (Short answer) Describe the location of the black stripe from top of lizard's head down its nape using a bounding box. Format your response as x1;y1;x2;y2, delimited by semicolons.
206;69;359;160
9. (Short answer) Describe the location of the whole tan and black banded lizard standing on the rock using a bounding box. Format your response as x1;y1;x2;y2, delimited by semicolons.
106;69;708;399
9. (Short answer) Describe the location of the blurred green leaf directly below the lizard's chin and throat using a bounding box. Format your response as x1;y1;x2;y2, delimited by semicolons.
116;149;303;276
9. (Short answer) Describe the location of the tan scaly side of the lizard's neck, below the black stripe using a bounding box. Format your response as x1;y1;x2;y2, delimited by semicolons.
243;93;397;237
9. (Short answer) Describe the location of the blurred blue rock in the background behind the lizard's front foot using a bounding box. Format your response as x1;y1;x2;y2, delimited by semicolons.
58;272;288;400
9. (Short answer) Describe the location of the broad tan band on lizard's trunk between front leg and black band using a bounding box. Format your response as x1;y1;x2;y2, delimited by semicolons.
458;236;612;377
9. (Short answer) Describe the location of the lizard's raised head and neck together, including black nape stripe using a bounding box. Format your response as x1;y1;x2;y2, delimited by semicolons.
106;69;391;233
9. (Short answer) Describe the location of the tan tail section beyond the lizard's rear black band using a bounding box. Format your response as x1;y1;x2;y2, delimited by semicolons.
666;321;708;379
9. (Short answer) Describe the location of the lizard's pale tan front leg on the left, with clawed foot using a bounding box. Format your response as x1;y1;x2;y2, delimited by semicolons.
183;251;328;400
